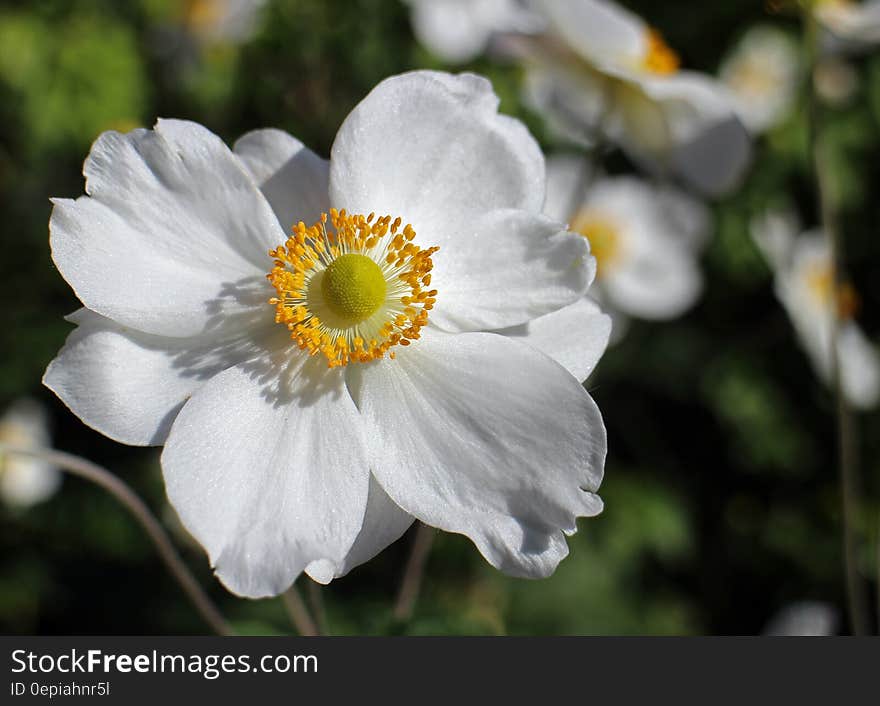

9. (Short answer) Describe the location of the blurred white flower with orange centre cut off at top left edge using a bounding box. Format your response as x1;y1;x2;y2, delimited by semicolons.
181;0;266;44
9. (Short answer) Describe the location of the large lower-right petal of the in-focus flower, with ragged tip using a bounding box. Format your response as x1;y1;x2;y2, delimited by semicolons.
349;331;606;576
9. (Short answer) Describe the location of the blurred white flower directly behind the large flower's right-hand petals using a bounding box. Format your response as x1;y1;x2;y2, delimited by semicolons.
544;156;709;336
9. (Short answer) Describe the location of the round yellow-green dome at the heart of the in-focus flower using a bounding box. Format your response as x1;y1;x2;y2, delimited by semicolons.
321;253;388;324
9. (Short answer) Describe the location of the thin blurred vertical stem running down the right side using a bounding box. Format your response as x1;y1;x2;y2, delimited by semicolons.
805;6;869;635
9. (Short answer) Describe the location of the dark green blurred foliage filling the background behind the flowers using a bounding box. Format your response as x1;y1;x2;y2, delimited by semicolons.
0;0;880;634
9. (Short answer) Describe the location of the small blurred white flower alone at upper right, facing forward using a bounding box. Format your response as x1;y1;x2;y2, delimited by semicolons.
719;25;801;134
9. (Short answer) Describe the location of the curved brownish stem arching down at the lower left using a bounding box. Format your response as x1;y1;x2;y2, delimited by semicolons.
0;444;234;635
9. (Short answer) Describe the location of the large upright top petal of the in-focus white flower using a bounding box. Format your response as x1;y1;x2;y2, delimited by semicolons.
330;71;544;247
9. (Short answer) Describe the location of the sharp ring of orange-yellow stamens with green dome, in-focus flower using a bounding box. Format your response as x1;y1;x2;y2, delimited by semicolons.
266;209;438;368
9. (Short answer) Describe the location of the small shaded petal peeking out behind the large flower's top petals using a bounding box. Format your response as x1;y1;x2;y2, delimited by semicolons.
233;128;330;232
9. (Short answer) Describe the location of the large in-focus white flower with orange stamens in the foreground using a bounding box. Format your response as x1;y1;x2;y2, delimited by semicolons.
45;72;607;596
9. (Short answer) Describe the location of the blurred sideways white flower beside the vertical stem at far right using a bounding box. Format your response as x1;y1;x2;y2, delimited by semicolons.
752;211;880;409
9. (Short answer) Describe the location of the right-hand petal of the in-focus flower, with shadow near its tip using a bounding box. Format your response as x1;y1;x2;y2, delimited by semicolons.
431;211;596;331
